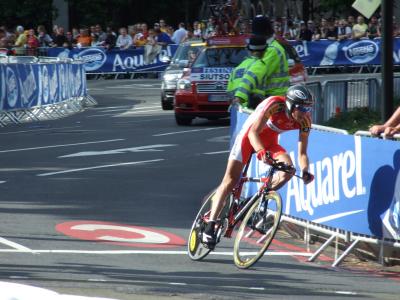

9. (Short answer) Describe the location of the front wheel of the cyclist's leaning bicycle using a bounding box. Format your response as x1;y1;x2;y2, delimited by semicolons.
233;191;282;269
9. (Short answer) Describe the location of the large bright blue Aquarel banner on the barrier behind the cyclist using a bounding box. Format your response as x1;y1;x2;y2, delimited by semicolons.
232;106;400;240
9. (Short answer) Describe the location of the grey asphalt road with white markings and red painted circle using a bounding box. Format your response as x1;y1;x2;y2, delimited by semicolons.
0;80;400;300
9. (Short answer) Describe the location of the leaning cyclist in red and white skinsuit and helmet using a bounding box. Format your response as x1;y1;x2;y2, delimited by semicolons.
202;84;314;249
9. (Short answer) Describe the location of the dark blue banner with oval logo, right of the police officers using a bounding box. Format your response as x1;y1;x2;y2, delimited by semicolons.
290;38;400;67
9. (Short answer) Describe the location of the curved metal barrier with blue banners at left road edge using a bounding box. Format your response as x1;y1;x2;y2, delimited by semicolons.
0;56;96;127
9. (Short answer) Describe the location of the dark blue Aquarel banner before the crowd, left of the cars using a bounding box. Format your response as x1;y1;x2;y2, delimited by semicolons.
47;45;178;73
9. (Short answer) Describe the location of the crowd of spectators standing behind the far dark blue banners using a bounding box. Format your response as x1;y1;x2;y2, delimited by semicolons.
0;11;400;55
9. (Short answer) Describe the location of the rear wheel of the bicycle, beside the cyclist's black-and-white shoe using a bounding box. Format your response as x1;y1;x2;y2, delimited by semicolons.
188;190;215;260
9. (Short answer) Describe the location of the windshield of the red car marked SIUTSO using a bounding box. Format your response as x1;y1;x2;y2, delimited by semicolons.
193;47;247;68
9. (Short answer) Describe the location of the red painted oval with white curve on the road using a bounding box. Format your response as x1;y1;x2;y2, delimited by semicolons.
55;221;186;248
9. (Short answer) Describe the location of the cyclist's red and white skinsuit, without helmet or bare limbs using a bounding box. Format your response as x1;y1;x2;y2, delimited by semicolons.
230;96;311;163
